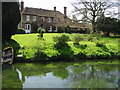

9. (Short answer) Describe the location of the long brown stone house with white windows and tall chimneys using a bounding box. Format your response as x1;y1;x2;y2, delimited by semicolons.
19;2;88;33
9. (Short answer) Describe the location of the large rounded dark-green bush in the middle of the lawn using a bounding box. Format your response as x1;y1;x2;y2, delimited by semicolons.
53;34;70;48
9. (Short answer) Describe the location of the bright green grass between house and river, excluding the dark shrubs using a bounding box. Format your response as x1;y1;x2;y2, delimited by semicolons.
12;33;119;59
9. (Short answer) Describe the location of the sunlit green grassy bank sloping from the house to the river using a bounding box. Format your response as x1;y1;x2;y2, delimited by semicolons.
12;33;120;61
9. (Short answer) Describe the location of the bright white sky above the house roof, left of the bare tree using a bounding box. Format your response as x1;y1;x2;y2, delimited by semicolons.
19;0;75;17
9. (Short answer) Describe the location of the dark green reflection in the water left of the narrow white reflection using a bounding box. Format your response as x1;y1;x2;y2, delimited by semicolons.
2;65;22;88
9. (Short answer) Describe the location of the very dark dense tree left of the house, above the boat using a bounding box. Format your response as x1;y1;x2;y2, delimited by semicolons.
2;2;20;39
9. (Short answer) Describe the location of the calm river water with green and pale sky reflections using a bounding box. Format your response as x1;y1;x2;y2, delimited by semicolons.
2;59;120;88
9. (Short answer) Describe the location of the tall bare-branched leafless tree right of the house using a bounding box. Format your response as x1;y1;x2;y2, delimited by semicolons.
72;0;113;32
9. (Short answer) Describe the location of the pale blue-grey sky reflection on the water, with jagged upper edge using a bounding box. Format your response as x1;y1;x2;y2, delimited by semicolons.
23;72;67;88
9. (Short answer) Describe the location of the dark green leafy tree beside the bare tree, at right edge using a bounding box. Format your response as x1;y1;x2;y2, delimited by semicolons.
97;16;120;36
